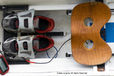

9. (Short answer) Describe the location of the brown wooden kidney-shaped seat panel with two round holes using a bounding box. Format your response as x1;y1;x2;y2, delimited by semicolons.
71;2;112;65
